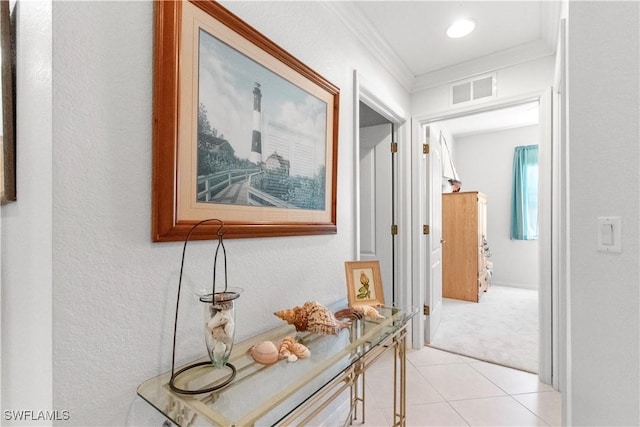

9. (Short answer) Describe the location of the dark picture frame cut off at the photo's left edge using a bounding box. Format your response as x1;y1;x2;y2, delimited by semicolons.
0;1;18;204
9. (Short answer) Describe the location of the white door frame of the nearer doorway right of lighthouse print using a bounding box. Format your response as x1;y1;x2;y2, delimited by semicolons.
353;70;412;308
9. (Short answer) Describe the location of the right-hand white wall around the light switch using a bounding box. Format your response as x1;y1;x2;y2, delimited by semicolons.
568;2;640;426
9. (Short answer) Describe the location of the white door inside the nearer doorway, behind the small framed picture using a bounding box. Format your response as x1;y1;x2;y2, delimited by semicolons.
360;124;394;305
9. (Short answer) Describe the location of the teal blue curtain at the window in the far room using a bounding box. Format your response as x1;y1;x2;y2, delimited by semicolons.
511;145;538;240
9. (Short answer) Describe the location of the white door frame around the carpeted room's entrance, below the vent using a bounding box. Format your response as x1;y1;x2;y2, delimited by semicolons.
412;89;563;388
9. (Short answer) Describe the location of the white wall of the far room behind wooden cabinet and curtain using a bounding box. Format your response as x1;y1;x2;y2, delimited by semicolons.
455;125;540;289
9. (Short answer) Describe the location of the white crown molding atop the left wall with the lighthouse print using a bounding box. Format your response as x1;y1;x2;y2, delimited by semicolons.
323;1;415;92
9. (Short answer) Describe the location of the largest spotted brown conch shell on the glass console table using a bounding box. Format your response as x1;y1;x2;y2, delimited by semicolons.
274;301;350;335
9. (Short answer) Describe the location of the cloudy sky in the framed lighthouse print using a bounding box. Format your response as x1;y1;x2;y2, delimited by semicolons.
199;30;327;165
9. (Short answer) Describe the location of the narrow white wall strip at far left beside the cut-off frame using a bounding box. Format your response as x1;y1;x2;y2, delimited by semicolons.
0;1;54;425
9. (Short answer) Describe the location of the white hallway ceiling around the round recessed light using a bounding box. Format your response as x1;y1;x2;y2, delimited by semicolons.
354;1;555;81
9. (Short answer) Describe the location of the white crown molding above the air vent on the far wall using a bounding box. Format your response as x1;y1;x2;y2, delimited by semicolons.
411;40;554;92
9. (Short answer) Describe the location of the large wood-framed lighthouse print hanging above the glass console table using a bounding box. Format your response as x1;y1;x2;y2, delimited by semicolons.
152;0;340;241
